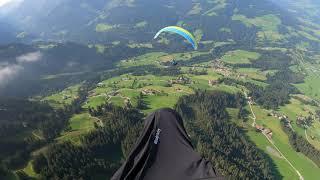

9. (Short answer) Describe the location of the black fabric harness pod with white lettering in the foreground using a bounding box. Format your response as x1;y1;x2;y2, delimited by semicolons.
111;109;224;180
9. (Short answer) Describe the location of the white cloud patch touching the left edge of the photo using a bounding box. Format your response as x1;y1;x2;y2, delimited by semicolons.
0;64;23;87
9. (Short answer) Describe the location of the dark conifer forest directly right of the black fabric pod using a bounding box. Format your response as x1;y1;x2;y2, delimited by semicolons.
176;91;281;179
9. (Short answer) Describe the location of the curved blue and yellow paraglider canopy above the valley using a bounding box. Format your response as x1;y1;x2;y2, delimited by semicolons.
154;26;198;50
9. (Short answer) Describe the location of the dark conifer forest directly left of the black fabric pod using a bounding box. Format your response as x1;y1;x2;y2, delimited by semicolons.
33;104;143;179
